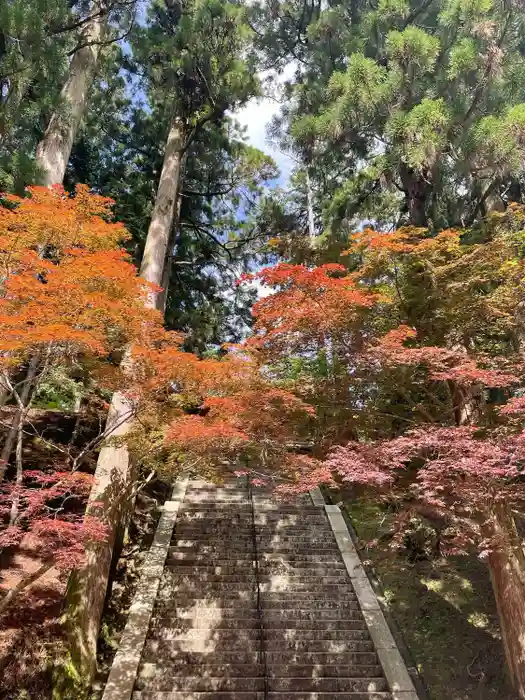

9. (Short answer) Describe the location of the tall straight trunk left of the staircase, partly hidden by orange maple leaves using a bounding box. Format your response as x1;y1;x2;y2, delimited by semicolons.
63;119;185;698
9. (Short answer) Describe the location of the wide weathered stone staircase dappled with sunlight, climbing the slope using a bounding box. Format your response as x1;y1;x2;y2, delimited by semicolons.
103;480;417;700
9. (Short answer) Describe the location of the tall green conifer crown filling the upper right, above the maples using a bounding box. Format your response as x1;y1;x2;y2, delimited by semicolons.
253;0;525;231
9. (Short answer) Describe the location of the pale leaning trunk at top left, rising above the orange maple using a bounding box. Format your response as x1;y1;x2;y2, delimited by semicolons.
36;0;108;186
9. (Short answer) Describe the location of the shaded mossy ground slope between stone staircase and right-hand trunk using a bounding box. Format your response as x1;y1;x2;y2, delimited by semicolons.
346;499;516;700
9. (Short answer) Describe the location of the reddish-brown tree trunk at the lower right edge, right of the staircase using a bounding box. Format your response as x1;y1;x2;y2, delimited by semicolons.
483;503;525;700
